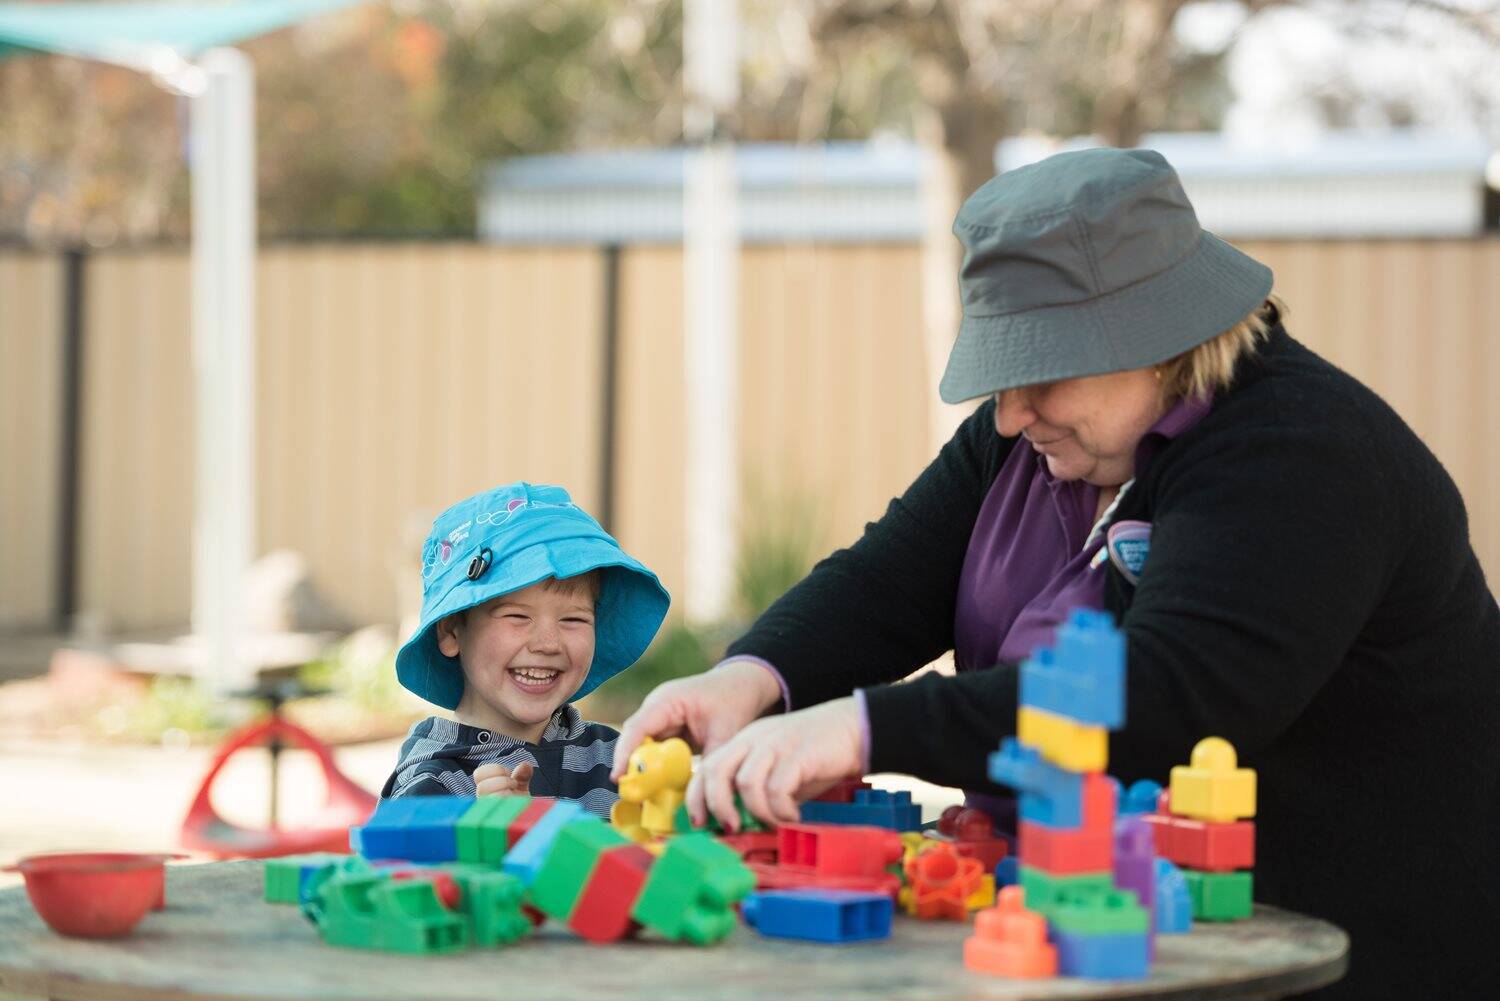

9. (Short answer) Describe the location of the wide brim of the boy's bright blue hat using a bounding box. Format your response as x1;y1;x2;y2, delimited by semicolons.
396;539;671;710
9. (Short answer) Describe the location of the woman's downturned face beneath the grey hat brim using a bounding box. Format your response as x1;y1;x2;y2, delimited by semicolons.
995;369;1166;486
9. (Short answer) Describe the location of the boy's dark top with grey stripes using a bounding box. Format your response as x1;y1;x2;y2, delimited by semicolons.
381;704;620;816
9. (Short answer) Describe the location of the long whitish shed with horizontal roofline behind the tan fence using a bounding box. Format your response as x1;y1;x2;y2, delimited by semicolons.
479;132;1500;243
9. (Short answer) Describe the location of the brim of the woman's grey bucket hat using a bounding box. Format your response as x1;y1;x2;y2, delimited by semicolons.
938;231;1272;404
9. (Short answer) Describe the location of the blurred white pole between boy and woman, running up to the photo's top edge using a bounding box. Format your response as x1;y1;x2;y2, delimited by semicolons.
683;0;740;623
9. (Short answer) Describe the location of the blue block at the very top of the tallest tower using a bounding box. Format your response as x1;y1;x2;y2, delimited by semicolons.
1020;608;1125;729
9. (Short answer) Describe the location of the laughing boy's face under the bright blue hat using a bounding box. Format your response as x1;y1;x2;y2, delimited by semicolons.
437;573;599;743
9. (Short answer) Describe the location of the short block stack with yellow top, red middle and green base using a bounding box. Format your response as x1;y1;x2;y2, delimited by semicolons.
1145;737;1256;921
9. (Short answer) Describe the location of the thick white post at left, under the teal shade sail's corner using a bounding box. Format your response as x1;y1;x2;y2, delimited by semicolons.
191;48;255;692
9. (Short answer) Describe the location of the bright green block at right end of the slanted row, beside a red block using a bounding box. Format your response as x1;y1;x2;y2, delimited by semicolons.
630;833;755;945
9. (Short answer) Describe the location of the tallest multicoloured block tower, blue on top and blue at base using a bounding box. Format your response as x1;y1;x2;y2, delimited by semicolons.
971;609;1155;978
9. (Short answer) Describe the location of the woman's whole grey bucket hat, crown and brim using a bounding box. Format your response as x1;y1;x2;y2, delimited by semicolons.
939;149;1271;404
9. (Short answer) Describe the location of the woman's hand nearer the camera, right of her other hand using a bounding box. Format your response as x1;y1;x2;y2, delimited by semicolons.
687;698;864;831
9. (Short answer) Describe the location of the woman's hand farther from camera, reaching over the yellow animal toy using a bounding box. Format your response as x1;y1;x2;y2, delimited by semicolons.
609;660;782;782
